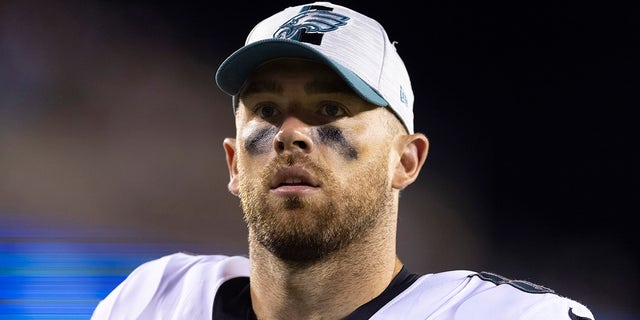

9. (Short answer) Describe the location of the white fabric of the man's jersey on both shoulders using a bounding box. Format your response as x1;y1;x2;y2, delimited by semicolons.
92;253;595;320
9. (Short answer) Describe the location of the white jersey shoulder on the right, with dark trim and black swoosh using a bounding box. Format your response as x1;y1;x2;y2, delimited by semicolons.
372;270;595;320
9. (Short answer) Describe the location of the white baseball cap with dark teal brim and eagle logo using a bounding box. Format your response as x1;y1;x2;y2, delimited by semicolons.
215;2;413;133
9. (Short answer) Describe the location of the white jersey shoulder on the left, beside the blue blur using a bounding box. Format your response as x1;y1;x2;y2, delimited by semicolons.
92;253;249;319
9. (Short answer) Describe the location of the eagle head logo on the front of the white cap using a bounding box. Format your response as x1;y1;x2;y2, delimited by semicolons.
273;8;349;45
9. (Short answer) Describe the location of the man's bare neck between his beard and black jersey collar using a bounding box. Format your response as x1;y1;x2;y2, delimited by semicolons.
249;215;402;319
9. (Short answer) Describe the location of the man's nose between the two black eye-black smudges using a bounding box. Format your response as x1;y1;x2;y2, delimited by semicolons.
274;116;313;153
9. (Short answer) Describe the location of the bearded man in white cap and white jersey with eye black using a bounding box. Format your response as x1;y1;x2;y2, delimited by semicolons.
93;2;594;320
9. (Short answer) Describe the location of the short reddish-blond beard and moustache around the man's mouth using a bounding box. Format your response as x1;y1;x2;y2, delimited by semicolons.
239;157;392;263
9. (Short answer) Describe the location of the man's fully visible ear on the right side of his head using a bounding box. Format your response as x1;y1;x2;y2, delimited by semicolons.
391;133;429;190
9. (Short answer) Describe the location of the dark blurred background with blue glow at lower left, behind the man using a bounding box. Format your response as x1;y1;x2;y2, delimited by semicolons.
0;0;640;320
